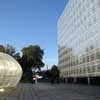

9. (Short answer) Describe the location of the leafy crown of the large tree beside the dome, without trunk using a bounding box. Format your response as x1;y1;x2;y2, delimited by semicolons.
22;45;44;70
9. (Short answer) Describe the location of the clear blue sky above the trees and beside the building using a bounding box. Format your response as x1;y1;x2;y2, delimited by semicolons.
0;0;66;68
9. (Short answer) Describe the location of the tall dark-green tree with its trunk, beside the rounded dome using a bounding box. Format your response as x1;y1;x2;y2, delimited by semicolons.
20;45;44;81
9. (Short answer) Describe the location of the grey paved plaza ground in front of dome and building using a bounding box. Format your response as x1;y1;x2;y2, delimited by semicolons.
0;83;100;100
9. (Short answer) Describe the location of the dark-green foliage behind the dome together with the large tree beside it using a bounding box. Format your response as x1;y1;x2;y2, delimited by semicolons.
0;44;44;82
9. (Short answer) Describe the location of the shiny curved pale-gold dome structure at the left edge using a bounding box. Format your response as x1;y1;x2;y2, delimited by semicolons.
0;53;22;88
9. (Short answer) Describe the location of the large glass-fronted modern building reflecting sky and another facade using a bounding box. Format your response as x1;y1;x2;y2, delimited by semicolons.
57;0;100;82
